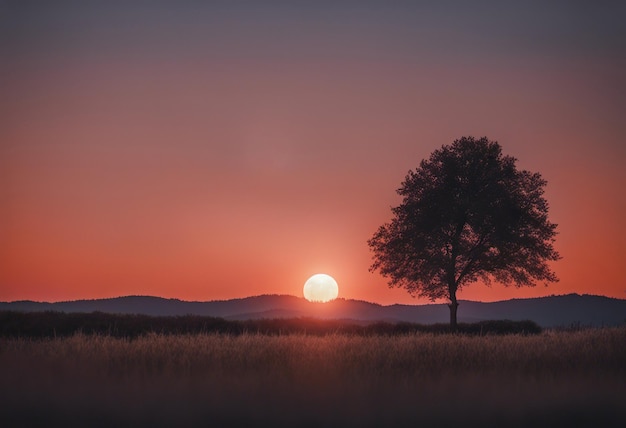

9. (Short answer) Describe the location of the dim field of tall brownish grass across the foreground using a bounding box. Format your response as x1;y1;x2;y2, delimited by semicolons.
0;328;626;427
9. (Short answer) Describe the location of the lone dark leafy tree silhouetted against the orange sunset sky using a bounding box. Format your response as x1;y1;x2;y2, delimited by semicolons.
368;137;560;329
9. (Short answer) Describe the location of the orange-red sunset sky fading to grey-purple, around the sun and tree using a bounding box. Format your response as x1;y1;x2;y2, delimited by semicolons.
0;0;626;304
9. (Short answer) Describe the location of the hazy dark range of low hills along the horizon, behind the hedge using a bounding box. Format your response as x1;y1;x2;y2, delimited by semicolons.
0;294;626;327
